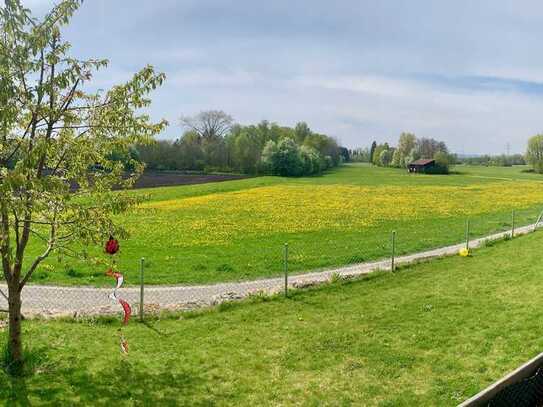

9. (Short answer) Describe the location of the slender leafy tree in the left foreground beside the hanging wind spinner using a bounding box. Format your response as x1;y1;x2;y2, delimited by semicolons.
0;0;167;372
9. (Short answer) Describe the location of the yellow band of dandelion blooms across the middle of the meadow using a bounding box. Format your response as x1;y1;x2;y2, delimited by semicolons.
140;182;543;245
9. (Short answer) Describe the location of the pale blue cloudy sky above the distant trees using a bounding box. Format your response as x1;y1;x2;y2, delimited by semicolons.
23;0;543;154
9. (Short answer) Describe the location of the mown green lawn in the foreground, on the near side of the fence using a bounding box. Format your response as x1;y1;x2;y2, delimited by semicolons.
0;232;543;406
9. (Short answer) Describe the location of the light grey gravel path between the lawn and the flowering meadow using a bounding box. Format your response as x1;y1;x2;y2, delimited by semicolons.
0;225;536;316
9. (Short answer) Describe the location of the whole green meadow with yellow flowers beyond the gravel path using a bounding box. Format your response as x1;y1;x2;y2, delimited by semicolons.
26;165;543;285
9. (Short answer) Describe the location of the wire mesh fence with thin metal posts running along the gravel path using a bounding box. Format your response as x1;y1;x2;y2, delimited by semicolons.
0;207;541;316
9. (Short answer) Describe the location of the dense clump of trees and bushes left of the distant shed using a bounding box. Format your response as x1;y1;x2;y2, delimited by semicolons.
134;111;342;176
